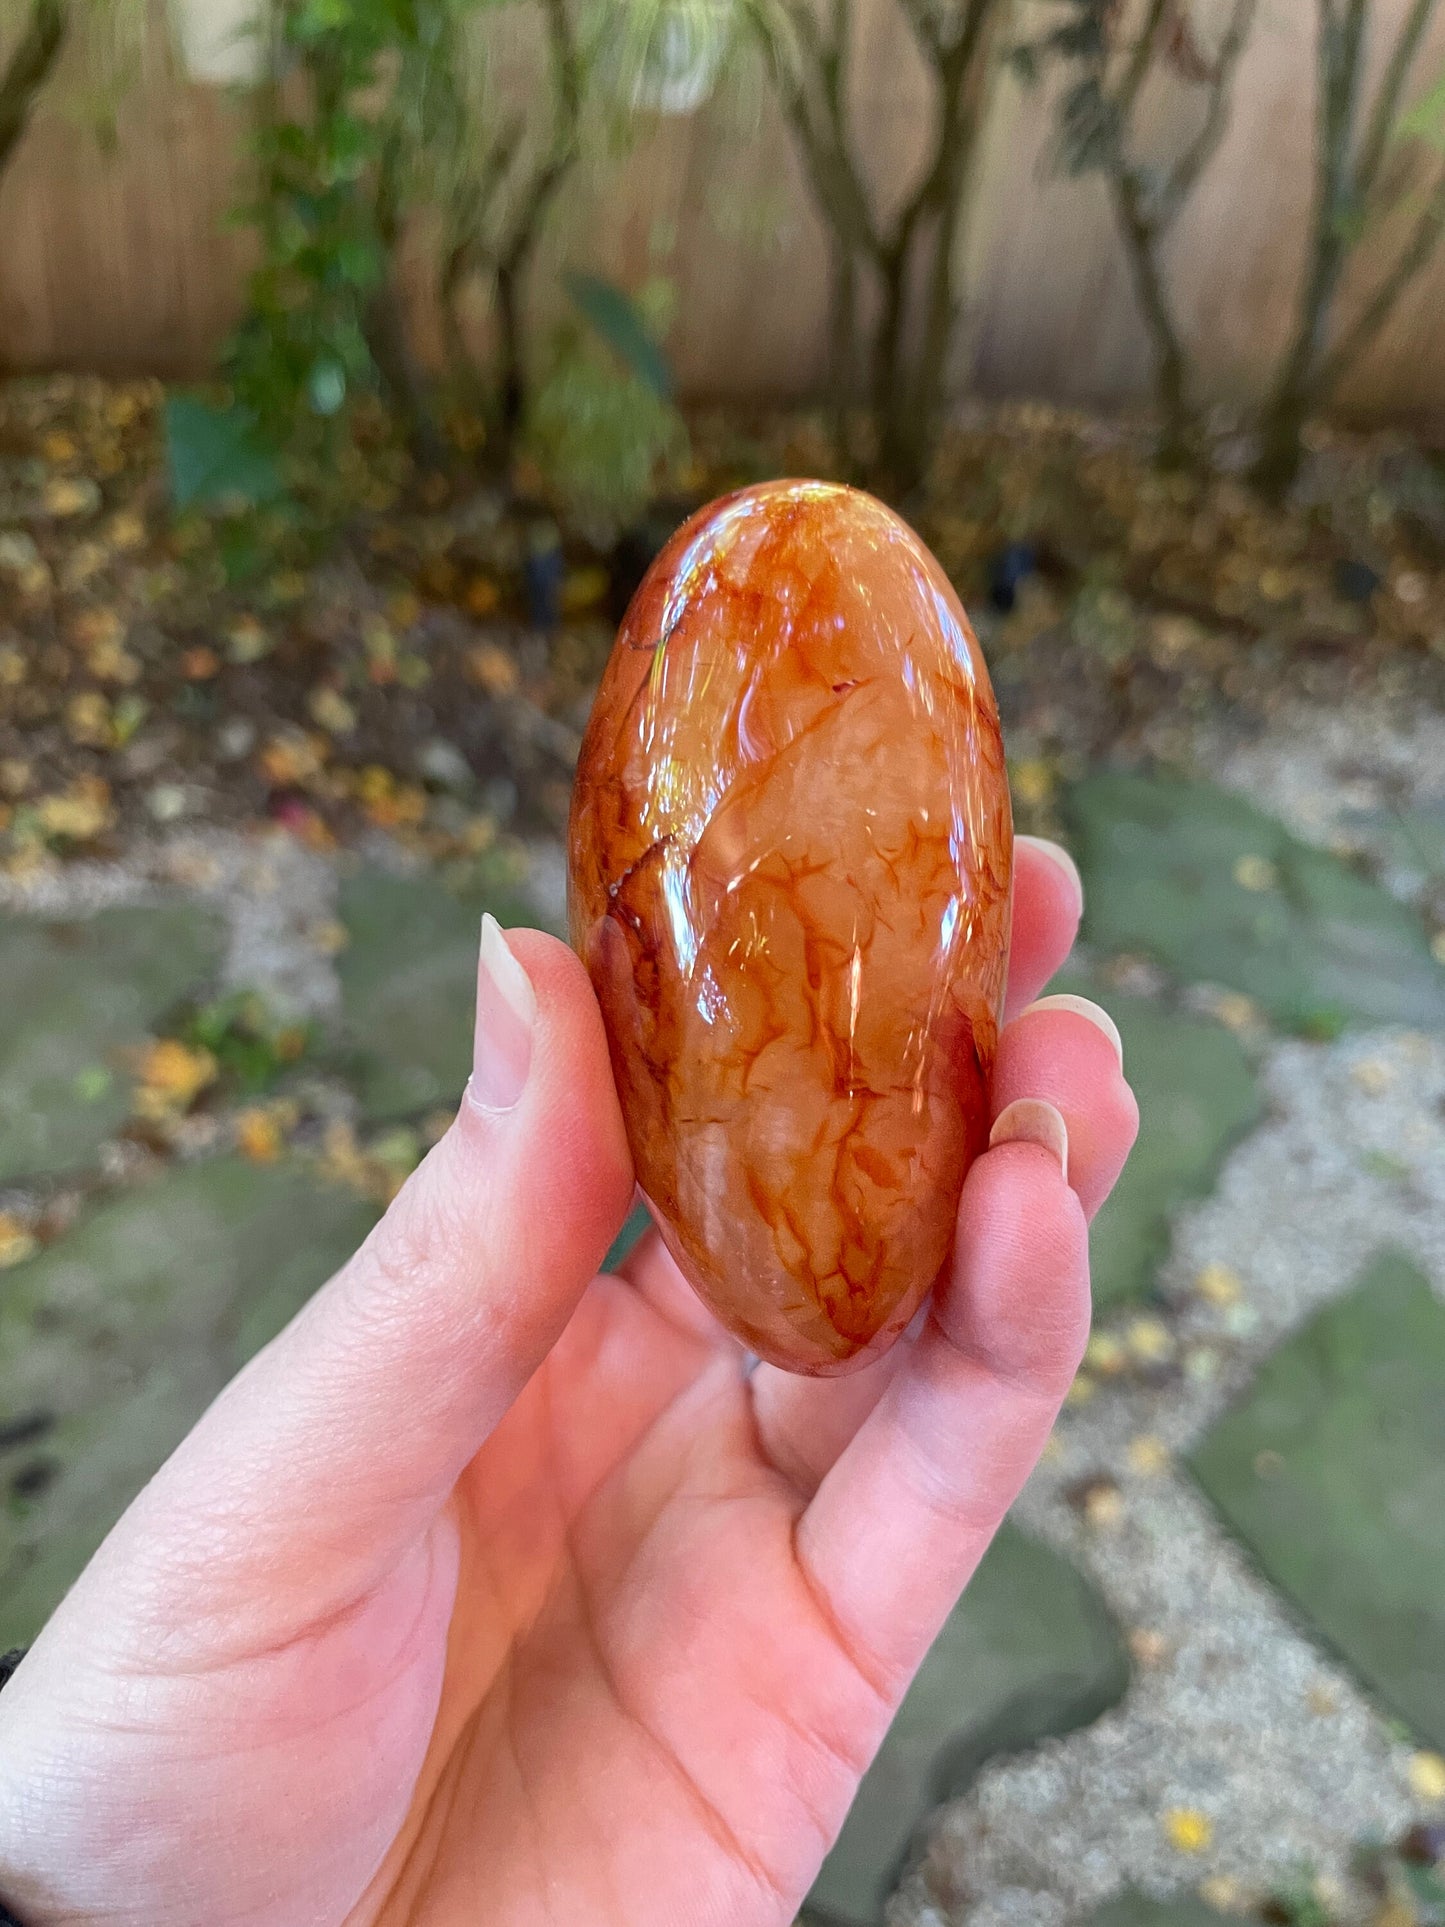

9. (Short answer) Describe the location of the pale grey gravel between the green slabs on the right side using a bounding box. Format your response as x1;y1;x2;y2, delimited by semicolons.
888;713;1445;1927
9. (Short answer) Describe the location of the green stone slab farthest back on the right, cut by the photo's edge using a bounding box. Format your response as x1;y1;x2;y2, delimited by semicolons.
1065;771;1445;1035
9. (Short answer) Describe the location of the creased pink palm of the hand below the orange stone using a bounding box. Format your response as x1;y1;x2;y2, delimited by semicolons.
355;1278;890;1927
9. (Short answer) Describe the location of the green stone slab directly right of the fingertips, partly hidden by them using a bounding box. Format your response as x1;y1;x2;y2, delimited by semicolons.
1048;971;1264;1305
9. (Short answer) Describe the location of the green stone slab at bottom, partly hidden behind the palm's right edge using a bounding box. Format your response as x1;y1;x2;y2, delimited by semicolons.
807;1526;1129;1927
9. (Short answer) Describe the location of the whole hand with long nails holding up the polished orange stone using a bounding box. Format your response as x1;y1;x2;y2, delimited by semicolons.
0;840;1137;1927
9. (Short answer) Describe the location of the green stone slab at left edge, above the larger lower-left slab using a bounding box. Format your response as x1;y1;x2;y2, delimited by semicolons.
0;904;223;1183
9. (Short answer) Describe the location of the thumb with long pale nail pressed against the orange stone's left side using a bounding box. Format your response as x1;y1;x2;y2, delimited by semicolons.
105;917;632;1621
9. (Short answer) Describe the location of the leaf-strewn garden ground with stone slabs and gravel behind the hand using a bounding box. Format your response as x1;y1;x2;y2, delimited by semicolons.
0;383;1445;1927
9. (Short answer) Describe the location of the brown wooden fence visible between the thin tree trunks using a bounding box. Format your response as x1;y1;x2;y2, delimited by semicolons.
0;0;1445;426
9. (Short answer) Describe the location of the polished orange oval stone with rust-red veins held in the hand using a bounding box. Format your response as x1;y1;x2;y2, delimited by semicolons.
568;482;1013;1374
